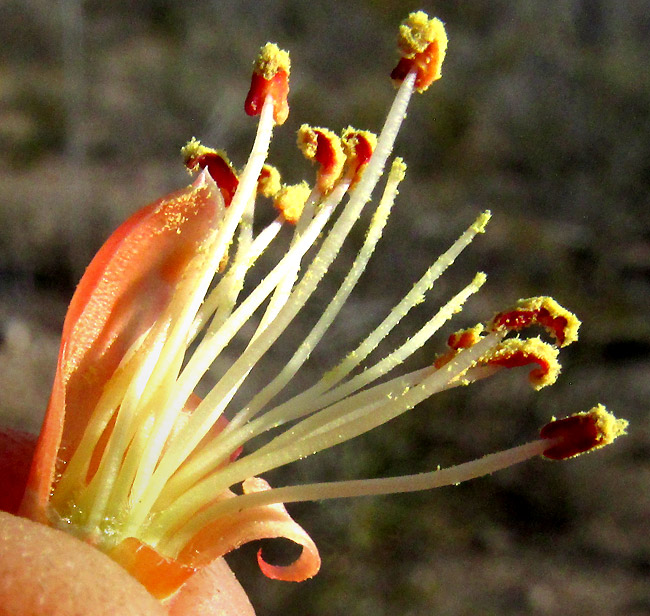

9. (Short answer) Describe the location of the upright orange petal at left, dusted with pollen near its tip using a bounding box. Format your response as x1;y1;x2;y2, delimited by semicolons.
22;173;223;520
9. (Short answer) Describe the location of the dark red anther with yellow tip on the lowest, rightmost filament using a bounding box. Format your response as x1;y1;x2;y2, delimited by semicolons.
539;404;628;460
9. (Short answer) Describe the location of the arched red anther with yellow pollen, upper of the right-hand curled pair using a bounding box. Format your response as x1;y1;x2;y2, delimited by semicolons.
488;297;580;347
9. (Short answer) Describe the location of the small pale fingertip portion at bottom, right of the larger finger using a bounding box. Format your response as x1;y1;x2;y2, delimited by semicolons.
167;558;255;616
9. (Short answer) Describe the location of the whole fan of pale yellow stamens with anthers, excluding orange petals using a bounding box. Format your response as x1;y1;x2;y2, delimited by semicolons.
46;13;623;556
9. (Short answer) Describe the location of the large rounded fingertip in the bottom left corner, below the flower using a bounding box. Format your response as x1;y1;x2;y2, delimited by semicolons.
0;512;167;616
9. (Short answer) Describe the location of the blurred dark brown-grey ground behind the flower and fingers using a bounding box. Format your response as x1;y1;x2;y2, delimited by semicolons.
0;0;650;616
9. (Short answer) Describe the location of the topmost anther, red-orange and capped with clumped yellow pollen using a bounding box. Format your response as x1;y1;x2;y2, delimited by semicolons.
390;11;447;92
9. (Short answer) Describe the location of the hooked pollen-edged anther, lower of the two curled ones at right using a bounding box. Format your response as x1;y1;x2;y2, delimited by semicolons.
478;338;560;389
